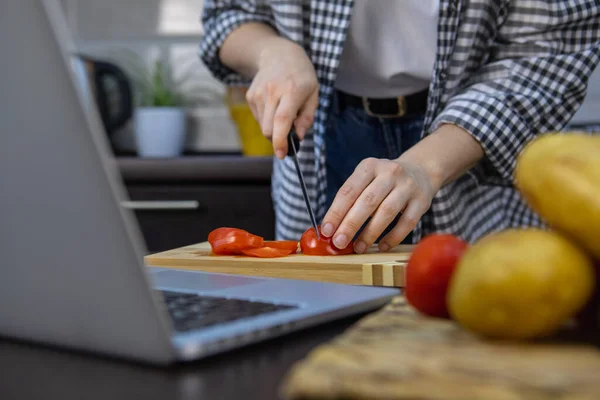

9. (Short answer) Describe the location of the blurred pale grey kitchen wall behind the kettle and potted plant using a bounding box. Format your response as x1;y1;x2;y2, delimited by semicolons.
60;0;240;152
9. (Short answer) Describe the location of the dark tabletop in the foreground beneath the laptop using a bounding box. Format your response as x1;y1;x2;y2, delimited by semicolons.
0;314;365;400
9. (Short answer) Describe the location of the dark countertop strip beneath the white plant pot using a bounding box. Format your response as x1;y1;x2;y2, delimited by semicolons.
116;155;273;183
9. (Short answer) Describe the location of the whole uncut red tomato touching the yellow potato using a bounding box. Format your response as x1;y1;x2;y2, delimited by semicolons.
404;234;468;318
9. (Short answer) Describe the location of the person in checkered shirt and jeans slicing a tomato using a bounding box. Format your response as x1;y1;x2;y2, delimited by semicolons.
200;0;600;253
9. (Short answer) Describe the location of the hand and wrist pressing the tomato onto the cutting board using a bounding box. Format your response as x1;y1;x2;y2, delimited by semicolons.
322;124;484;253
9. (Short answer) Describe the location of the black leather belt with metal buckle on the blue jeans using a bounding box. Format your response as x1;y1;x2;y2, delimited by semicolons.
337;90;428;118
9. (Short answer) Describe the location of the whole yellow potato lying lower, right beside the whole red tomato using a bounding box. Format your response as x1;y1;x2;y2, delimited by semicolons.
448;229;595;339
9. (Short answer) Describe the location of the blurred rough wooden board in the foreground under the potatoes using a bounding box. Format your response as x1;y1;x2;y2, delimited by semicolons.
281;297;600;400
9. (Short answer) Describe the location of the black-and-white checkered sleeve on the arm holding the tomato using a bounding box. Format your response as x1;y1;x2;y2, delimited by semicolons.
429;0;600;184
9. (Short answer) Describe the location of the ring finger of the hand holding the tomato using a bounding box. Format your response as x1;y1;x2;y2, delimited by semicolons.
354;188;411;253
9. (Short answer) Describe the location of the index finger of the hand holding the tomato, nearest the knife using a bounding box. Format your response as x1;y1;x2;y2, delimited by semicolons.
321;158;377;241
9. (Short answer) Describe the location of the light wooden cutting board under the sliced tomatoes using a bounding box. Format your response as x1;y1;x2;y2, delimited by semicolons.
144;242;413;287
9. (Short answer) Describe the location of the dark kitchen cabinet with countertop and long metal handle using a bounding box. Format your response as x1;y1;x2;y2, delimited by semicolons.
117;156;275;253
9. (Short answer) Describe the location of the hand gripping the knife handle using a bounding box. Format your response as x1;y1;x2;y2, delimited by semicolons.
246;37;319;159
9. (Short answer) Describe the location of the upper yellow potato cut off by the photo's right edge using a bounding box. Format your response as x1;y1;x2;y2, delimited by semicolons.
515;133;600;259
